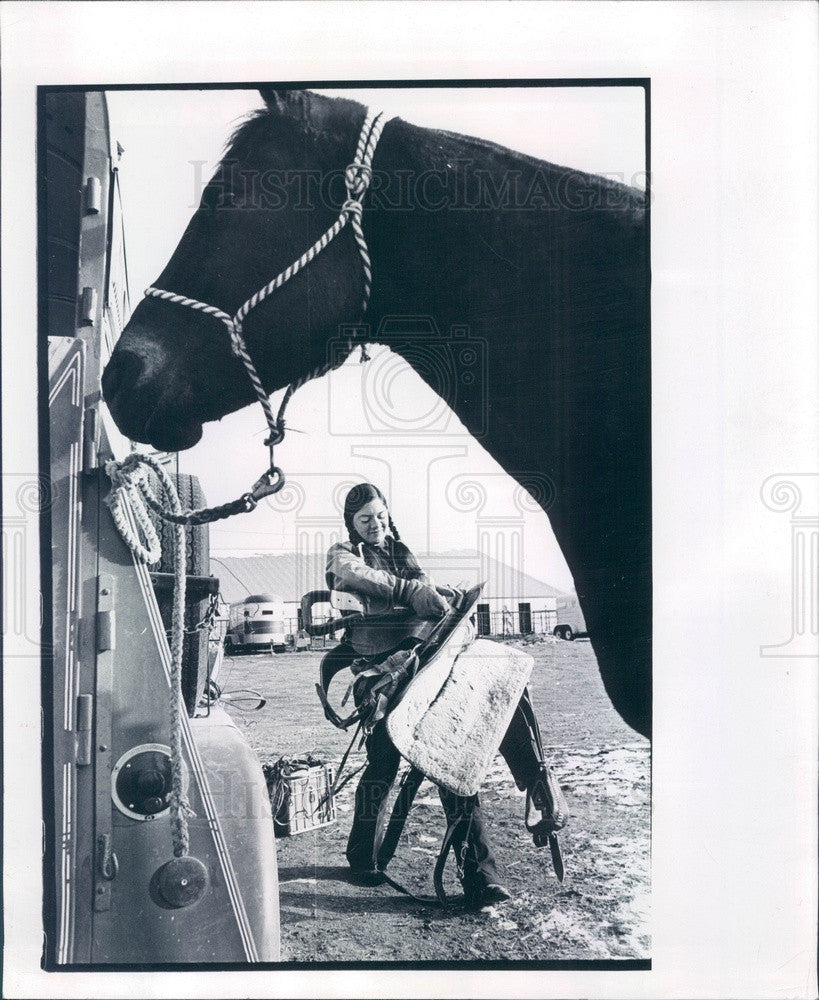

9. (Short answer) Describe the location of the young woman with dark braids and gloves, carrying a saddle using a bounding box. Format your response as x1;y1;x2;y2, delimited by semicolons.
327;483;567;908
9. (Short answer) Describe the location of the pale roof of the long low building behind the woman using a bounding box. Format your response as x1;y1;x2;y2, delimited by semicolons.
210;549;565;604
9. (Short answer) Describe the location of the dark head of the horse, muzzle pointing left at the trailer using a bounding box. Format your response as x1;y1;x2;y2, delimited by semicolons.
102;90;374;451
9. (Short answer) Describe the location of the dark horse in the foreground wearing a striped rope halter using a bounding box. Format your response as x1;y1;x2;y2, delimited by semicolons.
102;90;651;734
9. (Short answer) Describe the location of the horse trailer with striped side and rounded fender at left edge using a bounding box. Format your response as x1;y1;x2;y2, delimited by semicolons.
38;90;279;969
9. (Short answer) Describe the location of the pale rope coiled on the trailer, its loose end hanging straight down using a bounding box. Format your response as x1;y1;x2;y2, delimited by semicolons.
105;453;195;858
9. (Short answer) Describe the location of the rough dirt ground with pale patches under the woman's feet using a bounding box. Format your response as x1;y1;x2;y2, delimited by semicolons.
219;640;650;963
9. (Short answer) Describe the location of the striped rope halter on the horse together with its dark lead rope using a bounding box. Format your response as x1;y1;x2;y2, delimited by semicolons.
145;112;384;524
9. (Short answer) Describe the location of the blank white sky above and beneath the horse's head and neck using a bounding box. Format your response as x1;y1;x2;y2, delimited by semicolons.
107;87;645;589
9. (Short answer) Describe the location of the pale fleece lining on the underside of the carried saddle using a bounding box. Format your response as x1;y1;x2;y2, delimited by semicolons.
387;639;533;795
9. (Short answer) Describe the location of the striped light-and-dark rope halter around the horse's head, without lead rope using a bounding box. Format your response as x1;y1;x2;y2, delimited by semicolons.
145;112;385;506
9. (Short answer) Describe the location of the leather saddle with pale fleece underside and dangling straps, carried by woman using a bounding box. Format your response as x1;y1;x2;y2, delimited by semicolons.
302;584;568;905
